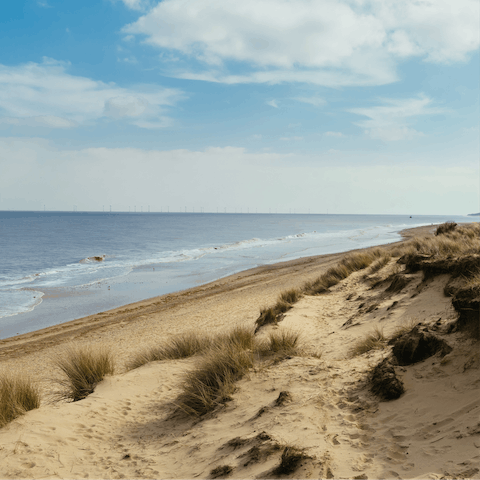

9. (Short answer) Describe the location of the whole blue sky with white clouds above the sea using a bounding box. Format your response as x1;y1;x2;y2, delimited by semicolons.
0;0;480;215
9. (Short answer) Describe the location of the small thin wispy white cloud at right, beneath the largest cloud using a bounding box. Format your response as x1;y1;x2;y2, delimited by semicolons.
349;95;443;141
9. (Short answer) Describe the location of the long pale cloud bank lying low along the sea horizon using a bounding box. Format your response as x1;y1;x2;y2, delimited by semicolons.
0;138;478;214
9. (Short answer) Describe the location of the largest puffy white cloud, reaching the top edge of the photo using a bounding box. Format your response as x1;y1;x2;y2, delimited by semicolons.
123;0;479;86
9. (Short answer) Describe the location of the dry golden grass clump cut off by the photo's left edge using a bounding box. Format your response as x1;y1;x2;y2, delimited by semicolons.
0;373;40;427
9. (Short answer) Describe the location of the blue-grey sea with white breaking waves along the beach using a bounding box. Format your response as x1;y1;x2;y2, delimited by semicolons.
0;211;474;338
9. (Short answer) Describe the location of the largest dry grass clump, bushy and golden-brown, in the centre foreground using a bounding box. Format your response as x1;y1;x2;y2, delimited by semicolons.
177;342;253;416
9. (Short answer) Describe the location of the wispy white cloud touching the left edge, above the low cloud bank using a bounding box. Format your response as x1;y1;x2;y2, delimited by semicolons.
0;58;182;128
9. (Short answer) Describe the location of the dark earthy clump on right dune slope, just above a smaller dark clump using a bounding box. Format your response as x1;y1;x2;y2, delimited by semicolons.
392;325;452;365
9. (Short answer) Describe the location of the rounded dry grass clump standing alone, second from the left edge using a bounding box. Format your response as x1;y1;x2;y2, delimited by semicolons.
53;346;115;402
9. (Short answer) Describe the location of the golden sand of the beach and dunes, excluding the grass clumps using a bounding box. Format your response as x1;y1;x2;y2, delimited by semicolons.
0;228;480;480
